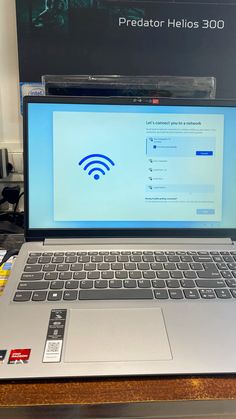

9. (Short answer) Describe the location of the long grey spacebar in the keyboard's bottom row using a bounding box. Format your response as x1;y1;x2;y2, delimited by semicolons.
79;289;153;300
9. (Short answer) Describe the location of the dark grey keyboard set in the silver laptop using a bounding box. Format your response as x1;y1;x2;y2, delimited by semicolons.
13;251;236;302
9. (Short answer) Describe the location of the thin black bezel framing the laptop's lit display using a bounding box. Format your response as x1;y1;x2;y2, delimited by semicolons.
23;96;236;241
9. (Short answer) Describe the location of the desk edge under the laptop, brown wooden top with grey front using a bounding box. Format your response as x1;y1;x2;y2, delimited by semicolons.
0;376;236;419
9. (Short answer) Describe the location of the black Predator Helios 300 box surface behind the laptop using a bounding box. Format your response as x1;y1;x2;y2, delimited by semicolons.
16;0;236;98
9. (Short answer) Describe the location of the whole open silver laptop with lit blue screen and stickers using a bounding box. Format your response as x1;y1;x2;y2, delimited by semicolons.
0;97;236;379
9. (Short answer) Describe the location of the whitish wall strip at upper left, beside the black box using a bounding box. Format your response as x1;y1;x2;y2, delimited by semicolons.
0;0;22;161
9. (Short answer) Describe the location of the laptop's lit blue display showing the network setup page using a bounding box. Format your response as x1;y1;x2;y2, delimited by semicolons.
25;97;236;238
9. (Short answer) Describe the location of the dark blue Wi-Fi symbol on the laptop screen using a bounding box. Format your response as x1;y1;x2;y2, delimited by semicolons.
79;154;115;180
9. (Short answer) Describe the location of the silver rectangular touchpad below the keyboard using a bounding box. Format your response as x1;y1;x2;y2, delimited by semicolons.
64;308;172;362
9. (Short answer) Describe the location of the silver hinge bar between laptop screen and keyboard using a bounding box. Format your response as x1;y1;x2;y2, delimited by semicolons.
44;237;234;246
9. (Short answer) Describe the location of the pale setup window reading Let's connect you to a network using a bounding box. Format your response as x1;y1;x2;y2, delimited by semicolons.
53;112;224;221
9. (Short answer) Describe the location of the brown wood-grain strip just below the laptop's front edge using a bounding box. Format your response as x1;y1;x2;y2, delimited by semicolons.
0;376;236;407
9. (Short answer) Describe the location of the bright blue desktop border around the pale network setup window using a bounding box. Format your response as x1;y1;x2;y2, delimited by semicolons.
28;103;236;229
